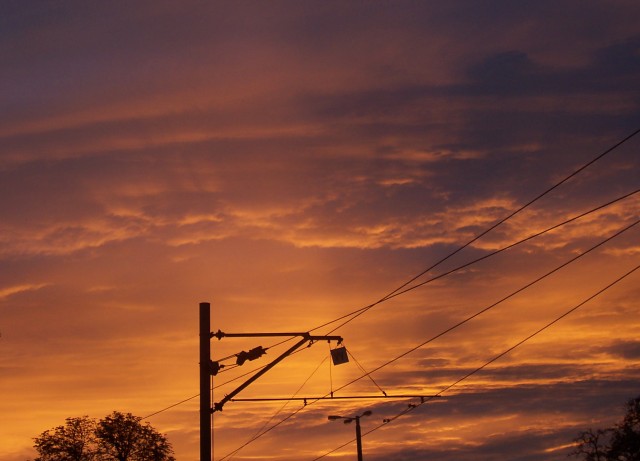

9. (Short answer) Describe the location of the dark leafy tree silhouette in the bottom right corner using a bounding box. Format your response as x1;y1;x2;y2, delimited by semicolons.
571;397;640;461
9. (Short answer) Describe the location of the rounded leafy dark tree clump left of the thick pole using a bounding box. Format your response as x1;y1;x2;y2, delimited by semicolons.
34;411;175;461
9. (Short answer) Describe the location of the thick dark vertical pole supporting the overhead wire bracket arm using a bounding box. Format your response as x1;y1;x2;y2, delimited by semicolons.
200;303;211;461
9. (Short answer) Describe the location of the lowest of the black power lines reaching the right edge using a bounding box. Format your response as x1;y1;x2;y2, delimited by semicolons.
312;265;640;461
